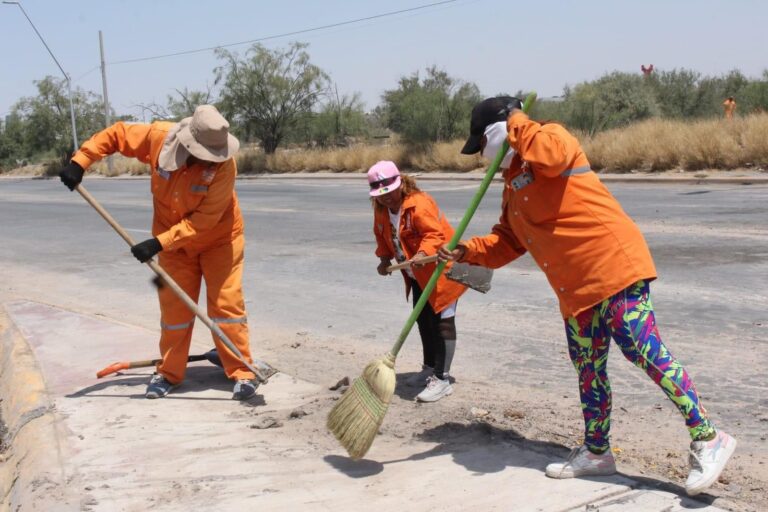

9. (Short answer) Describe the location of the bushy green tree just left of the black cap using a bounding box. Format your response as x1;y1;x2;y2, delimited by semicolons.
382;66;482;143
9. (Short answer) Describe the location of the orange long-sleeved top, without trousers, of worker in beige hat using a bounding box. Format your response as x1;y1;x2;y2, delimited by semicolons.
72;121;243;255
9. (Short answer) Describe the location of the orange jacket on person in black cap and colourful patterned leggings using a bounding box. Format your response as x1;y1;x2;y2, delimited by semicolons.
463;112;656;318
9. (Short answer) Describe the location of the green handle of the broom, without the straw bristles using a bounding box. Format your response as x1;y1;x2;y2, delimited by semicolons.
389;92;536;359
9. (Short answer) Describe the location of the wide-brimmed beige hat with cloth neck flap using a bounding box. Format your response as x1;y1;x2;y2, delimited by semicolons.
158;105;240;171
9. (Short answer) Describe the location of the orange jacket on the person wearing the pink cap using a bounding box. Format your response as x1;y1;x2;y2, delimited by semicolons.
373;192;467;313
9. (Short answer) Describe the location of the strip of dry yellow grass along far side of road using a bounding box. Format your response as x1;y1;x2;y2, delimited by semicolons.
3;113;768;176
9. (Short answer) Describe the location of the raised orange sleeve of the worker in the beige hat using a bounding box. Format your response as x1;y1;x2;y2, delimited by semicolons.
72;121;152;169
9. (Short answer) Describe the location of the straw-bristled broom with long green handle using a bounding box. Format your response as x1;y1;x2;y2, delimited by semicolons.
326;93;536;459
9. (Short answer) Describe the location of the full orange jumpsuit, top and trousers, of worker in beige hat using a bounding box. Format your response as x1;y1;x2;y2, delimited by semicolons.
72;122;255;384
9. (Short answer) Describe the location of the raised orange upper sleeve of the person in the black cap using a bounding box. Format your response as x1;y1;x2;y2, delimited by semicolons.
507;112;580;178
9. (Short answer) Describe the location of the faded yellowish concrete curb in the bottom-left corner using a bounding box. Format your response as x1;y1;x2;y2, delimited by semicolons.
0;307;81;511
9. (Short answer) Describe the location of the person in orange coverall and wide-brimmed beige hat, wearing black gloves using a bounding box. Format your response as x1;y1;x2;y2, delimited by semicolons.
59;105;258;400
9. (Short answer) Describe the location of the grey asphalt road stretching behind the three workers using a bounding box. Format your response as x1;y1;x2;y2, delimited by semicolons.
0;178;768;428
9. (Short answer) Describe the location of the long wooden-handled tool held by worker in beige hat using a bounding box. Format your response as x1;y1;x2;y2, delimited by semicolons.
75;183;277;384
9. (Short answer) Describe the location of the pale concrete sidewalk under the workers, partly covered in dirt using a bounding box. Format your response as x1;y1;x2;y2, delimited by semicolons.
0;301;720;512
